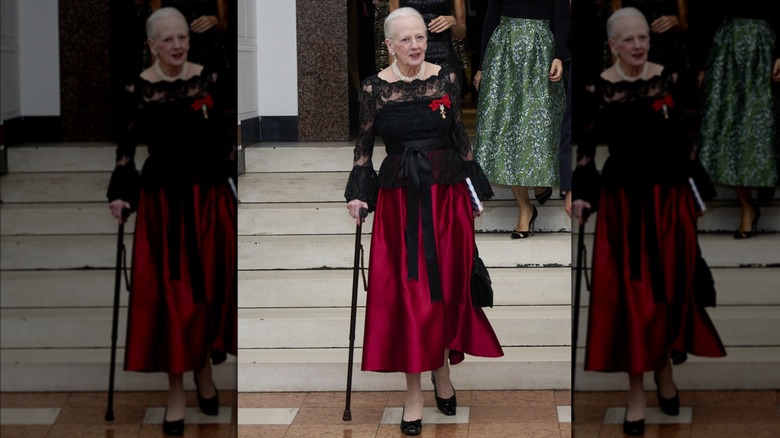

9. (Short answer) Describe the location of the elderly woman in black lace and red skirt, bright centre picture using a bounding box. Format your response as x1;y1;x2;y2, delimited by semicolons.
345;7;503;435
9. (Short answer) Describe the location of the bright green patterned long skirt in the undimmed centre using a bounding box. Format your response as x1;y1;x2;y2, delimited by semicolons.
474;17;566;187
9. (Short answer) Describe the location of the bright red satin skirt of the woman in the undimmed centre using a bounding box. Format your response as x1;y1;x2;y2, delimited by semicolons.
362;182;504;373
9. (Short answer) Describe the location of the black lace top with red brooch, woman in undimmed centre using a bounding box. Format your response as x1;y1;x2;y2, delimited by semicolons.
344;67;493;210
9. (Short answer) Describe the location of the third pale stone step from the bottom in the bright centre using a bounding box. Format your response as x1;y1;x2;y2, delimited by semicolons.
239;268;571;309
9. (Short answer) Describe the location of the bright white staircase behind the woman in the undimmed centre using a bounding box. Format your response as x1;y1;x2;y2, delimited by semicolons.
238;142;571;392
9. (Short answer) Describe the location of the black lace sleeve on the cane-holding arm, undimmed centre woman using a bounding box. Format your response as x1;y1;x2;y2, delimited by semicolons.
344;78;379;211
